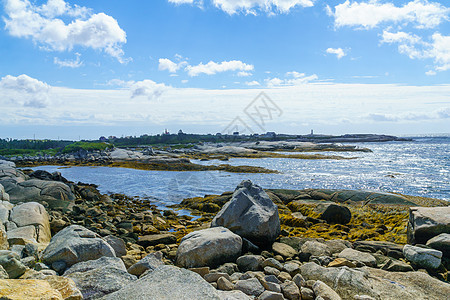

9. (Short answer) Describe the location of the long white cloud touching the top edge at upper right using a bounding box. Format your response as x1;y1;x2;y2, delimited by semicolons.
327;0;450;29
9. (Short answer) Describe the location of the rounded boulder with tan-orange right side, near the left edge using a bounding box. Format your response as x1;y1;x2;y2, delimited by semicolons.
9;202;52;244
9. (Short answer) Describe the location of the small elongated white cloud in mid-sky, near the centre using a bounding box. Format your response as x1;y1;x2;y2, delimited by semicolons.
185;60;254;77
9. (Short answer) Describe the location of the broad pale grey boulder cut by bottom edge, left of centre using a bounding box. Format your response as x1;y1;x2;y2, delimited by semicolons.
104;266;220;300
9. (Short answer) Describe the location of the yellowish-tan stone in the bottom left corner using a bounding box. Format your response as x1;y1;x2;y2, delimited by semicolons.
0;279;64;300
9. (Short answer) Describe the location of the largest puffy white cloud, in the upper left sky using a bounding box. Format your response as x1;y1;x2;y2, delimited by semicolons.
3;0;128;63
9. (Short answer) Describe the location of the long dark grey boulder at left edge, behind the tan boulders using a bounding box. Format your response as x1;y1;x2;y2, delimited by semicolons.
0;179;75;208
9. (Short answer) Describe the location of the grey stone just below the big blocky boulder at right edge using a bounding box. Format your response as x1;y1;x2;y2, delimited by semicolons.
403;245;442;269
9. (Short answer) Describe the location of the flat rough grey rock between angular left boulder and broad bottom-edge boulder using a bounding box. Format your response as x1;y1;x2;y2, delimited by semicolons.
65;267;137;299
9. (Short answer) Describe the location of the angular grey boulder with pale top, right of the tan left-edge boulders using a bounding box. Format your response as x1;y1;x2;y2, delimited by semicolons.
42;225;115;267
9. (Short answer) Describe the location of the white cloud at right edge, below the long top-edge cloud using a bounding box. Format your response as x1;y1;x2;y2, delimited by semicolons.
381;30;450;71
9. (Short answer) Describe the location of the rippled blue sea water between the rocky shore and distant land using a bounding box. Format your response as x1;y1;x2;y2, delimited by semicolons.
29;137;450;208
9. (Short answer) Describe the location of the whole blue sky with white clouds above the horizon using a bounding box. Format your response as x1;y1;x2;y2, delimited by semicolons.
0;0;450;140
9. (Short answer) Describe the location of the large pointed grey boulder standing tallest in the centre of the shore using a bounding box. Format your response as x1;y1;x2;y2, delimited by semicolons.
211;180;281;248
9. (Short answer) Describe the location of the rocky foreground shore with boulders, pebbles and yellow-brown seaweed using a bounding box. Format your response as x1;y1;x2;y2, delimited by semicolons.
0;160;450;300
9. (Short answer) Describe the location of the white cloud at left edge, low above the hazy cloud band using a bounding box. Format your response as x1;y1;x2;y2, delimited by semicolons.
0;74;50;108
